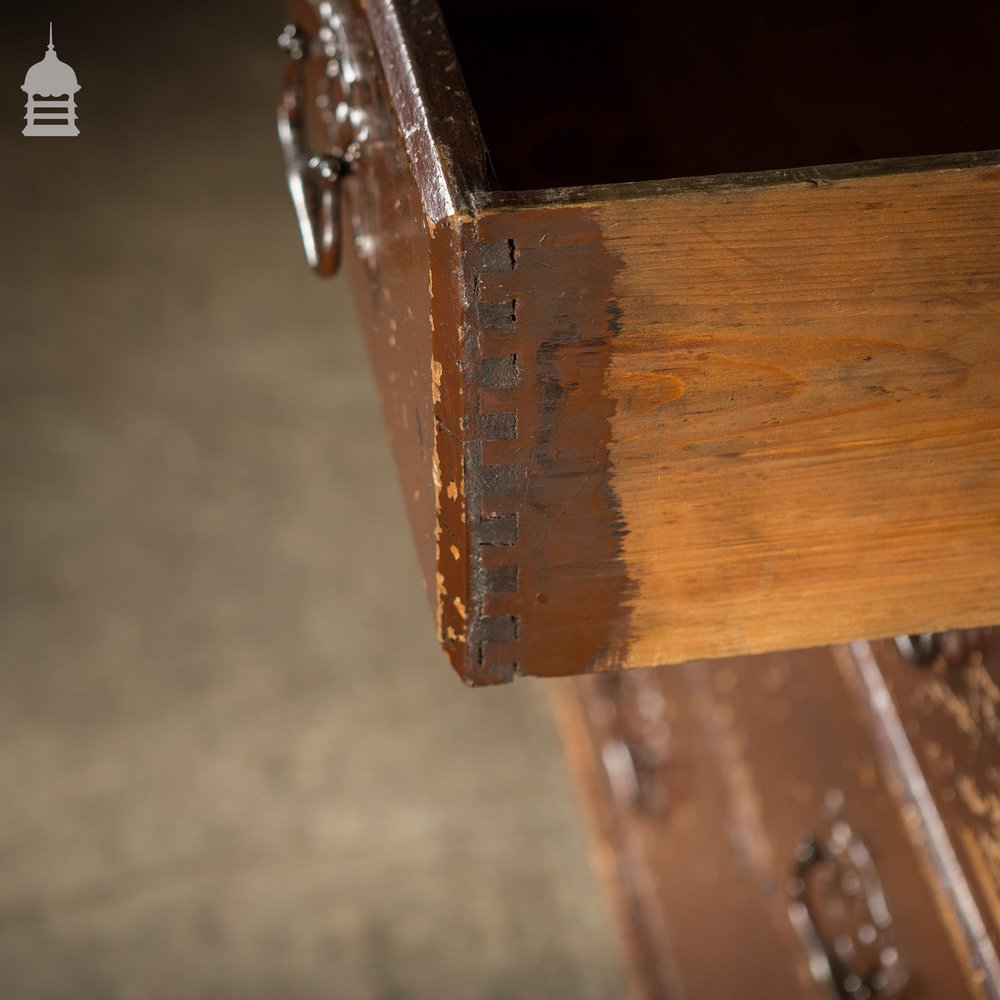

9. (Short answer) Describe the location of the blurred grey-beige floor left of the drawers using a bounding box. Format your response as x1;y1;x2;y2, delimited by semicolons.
0;2;624;1000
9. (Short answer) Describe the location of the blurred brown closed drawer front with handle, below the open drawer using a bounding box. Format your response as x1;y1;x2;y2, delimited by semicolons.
563;650;991;1000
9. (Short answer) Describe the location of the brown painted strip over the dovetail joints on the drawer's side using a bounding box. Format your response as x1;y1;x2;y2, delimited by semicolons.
466;210;629;680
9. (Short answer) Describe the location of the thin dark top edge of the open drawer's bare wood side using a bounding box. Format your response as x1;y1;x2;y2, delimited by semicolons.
479;150;1000;212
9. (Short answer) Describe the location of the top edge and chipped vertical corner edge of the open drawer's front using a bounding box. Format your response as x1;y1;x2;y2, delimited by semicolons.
346;0;490;684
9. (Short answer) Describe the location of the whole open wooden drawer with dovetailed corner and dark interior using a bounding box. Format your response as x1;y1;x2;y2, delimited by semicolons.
280;0;1000;684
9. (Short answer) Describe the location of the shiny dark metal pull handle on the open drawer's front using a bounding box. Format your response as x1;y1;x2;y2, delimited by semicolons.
278;24;359;277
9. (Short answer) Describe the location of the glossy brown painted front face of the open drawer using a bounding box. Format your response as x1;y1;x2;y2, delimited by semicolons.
281;0;436;596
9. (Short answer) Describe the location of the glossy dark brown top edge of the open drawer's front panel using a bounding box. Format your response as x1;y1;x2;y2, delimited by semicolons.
362;0;495;225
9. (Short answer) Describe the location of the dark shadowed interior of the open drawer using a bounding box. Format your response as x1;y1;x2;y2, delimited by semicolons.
442;0;1000;190
